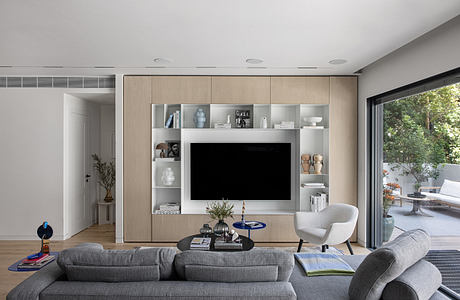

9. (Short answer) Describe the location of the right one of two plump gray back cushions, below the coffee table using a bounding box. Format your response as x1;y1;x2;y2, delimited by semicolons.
175;248;294;282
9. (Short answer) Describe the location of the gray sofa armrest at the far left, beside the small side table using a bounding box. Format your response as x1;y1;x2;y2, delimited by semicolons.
6;261;64;300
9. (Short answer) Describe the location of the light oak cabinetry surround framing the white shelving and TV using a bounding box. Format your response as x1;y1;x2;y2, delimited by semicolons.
123;76;357;242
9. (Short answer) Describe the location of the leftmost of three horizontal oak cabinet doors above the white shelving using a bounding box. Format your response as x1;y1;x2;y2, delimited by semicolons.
152;76;211;104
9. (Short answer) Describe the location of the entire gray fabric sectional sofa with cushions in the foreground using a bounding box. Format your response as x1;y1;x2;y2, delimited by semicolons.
7;231;448;300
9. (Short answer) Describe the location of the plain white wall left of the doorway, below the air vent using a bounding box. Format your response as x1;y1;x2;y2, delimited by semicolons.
0;89;64;240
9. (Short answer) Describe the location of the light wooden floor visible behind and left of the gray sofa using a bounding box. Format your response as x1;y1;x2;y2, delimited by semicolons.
0;225;369;299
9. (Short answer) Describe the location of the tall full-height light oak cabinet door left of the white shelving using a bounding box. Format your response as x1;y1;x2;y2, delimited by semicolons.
123;76;152;242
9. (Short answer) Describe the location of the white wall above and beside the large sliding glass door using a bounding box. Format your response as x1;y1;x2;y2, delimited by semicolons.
358;16;460;244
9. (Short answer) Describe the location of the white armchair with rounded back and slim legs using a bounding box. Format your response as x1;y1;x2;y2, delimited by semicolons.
294;204;358;254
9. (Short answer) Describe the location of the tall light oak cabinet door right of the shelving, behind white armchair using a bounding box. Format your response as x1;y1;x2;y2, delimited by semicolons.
329;77;358;206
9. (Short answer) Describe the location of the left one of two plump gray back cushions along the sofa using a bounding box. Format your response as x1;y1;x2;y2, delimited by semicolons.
57;243;175;282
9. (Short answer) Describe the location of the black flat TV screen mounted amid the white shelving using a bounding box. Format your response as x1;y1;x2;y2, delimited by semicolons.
190;143;291;200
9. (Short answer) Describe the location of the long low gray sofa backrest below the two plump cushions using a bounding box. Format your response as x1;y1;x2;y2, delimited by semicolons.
40;281;297;300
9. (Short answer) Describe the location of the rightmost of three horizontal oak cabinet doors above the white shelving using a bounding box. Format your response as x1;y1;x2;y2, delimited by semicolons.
271;77;330;104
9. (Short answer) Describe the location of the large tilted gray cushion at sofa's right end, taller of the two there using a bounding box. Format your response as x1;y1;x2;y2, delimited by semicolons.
348;229;431;300
